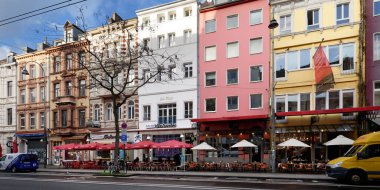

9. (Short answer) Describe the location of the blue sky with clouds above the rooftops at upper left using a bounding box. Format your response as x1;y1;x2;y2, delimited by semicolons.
0;0;174;59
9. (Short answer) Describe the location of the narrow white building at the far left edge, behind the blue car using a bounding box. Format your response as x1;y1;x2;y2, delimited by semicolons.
0;52;17;155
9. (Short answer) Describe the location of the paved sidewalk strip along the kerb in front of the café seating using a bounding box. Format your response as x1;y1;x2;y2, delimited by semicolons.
38;167;335;181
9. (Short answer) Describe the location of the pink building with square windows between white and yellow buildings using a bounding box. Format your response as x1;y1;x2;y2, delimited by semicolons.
193;0;270;161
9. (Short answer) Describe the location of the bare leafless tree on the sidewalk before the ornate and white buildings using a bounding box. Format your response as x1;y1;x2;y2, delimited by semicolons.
77;9;178;172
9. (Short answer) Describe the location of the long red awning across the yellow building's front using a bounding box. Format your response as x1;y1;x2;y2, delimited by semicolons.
276;106;380;116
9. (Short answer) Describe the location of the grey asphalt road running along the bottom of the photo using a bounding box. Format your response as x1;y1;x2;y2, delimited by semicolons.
0;172;380;190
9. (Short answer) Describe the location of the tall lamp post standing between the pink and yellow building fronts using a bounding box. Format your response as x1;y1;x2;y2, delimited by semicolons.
268;5;278;173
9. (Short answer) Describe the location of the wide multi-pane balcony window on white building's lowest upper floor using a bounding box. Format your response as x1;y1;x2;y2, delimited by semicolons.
158;104;177;124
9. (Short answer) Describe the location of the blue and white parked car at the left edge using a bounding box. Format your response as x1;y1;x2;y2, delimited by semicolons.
0;153;38;172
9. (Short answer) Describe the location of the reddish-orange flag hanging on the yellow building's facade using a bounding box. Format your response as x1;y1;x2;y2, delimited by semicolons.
313;46;334;92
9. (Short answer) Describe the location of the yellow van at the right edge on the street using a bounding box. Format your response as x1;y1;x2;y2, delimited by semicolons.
326;131;380;185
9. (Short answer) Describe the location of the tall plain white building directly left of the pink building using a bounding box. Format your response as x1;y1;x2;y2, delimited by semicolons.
136;0;198;159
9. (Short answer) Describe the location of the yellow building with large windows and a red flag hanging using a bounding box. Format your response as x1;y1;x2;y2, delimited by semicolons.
271;0;364;161
